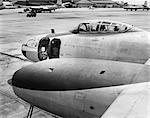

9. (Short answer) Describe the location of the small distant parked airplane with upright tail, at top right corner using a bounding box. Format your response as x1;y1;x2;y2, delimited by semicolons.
123;1;150;11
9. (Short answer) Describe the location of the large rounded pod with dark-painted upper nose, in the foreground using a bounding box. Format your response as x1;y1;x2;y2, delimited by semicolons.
12;58;150;118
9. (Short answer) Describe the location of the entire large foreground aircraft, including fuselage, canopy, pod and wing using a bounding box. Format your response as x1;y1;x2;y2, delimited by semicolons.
8;20;150;118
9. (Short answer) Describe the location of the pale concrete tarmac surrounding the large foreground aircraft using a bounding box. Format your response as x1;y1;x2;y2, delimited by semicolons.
0;8;150;118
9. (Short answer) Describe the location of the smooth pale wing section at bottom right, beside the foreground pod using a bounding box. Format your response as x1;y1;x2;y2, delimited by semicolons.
102;82;150;118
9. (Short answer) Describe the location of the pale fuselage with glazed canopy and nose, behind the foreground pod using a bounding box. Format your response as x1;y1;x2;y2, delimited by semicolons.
22;20;150;63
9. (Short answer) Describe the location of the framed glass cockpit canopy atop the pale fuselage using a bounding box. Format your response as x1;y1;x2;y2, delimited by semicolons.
71;20;133;34
